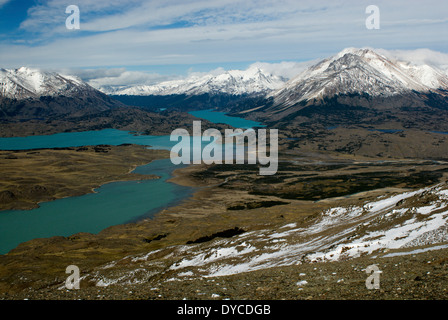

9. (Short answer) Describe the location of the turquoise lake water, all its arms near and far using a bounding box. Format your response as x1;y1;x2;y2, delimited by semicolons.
0;111;259;254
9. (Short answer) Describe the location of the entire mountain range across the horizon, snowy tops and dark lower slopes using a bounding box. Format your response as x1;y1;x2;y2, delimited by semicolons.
0;48;448;139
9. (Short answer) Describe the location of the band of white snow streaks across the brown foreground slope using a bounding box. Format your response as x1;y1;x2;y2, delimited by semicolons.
84;185;448;285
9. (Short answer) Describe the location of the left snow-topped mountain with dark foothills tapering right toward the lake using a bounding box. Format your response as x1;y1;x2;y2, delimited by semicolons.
0;67;224;137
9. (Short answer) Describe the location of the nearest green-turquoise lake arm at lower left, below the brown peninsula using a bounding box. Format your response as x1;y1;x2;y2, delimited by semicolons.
0;159;192;254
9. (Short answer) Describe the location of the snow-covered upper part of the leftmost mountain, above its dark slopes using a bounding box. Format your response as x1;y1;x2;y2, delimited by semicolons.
0;67;96;100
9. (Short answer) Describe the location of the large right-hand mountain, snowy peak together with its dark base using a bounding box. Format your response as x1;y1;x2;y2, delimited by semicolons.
238;48;448;125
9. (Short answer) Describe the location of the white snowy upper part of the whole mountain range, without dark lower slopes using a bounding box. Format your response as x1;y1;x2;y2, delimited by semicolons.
4;48;448;105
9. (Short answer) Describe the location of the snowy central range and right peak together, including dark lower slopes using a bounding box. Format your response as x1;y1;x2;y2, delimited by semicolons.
93;48;448;129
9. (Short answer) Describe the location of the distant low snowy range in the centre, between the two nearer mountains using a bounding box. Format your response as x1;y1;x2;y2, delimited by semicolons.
100;67;286;96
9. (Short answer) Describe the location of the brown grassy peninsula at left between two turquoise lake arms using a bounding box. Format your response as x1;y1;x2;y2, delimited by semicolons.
0;145;167;214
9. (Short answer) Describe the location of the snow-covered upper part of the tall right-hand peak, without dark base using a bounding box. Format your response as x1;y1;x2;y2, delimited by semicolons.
269;48;448;107
